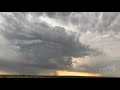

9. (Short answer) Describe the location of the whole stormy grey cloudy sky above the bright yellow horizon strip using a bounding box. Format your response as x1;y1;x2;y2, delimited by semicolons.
0;12;120;77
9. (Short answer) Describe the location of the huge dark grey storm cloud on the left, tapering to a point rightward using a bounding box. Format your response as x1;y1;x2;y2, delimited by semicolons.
0;12;98;74
